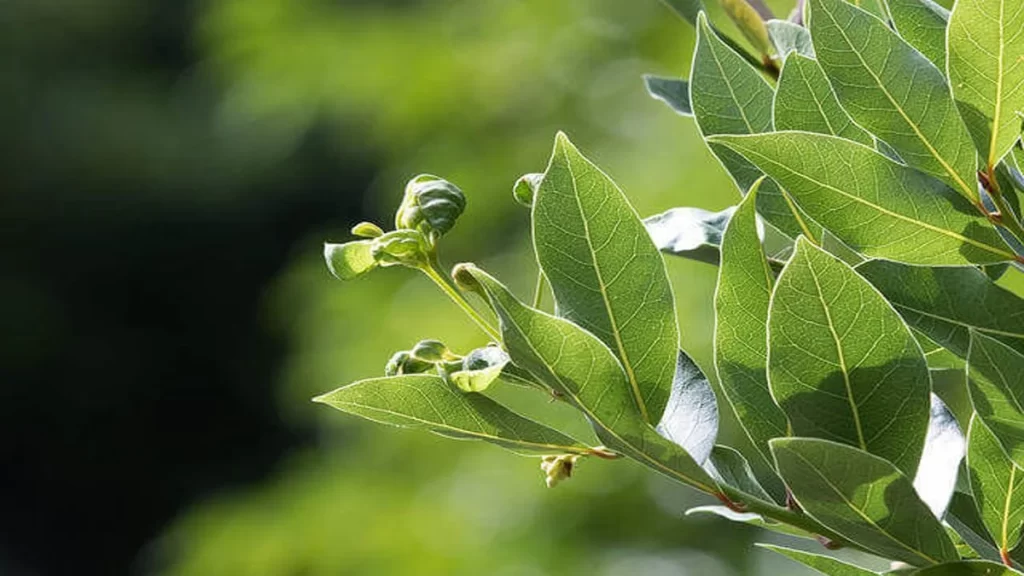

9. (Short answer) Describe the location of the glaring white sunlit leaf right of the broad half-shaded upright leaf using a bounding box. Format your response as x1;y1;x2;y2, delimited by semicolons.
913;394;967;520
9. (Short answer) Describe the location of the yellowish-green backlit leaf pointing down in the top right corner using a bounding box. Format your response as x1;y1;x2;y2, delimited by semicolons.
947;0;1024;167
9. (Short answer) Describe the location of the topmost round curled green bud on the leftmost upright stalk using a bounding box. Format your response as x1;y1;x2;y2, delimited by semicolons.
394;174;466;243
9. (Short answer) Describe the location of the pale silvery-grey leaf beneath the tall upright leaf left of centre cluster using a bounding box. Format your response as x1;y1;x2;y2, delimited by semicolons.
657;351;718;463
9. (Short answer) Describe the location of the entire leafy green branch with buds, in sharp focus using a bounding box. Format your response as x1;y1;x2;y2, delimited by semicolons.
315;0;1024;575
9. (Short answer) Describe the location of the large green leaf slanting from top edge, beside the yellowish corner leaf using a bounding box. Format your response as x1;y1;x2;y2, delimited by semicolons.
806;0;978;200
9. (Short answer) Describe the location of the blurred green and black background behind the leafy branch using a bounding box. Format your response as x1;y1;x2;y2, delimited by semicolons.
0;0;987;576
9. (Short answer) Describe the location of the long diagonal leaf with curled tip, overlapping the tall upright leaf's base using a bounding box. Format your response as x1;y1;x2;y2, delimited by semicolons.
456;264;717;492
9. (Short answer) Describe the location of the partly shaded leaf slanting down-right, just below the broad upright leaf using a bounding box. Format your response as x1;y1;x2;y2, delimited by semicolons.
771;438;958;566
